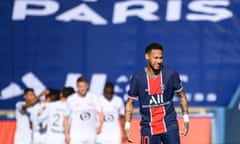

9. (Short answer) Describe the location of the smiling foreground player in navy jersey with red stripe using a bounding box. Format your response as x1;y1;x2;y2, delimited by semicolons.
125;43;189;144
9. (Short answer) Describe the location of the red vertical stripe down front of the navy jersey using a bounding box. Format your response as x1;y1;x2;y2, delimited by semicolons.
148;74;167;135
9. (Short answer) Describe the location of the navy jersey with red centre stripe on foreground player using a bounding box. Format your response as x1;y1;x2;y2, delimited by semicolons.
128;67;183;135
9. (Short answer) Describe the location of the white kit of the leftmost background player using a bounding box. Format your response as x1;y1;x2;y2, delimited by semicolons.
14;101;32;144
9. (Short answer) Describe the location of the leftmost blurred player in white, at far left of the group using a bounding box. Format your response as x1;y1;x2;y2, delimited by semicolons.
14;88;37;144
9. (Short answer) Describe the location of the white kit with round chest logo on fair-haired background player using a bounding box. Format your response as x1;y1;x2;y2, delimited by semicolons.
67;93;100;144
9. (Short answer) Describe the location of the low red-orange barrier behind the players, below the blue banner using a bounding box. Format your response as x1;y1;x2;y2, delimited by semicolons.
0;114;212;144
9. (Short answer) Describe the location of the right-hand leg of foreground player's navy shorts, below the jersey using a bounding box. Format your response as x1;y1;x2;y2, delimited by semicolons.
161;129;180;144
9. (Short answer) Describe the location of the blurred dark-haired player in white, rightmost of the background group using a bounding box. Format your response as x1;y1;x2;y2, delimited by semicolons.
97;82;124;144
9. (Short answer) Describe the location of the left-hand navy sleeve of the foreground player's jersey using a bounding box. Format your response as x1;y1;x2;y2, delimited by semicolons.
128;75;139;99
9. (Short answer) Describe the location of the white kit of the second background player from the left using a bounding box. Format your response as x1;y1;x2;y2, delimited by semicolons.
29;103;47;144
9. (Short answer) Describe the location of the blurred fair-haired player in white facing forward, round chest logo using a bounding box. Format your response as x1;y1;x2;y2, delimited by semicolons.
64;77;104;144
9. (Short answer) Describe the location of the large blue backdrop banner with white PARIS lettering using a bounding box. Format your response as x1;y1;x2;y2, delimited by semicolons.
0;0;240;109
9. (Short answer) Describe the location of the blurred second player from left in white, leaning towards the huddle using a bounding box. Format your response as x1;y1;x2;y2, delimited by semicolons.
29;89;60;144
